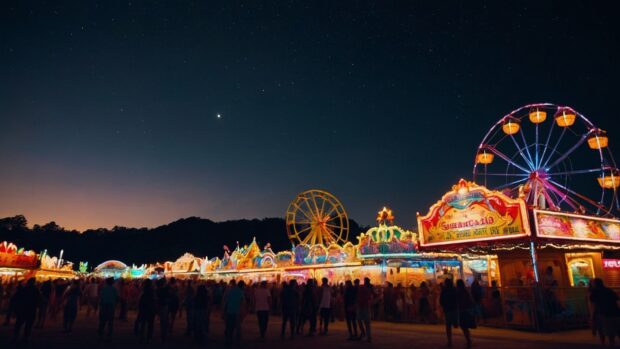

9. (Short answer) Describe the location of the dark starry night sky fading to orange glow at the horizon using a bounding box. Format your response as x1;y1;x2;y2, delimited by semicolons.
0;1;620;230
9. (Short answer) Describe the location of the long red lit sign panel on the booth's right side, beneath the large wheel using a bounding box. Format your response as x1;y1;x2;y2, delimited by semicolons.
534;210;620;243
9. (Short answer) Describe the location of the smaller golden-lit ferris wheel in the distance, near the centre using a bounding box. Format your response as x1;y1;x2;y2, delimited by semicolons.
286;190;349;246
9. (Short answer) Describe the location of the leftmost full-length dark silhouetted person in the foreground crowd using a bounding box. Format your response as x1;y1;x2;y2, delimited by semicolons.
13;278;41;343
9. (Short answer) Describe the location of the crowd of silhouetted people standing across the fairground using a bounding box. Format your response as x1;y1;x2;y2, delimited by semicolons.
0;278;620;347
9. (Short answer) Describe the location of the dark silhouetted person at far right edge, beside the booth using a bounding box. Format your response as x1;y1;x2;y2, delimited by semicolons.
590;278;620;347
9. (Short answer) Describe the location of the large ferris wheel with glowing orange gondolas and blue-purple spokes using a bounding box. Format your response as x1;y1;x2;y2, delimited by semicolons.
473;103;620;216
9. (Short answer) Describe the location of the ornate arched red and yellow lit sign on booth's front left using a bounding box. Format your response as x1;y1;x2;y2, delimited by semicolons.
418;179;530;246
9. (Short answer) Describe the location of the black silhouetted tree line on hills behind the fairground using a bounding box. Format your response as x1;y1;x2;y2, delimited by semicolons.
0;215;367;267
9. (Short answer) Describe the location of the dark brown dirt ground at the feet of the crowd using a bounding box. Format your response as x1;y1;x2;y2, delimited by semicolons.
0;311;599;349
